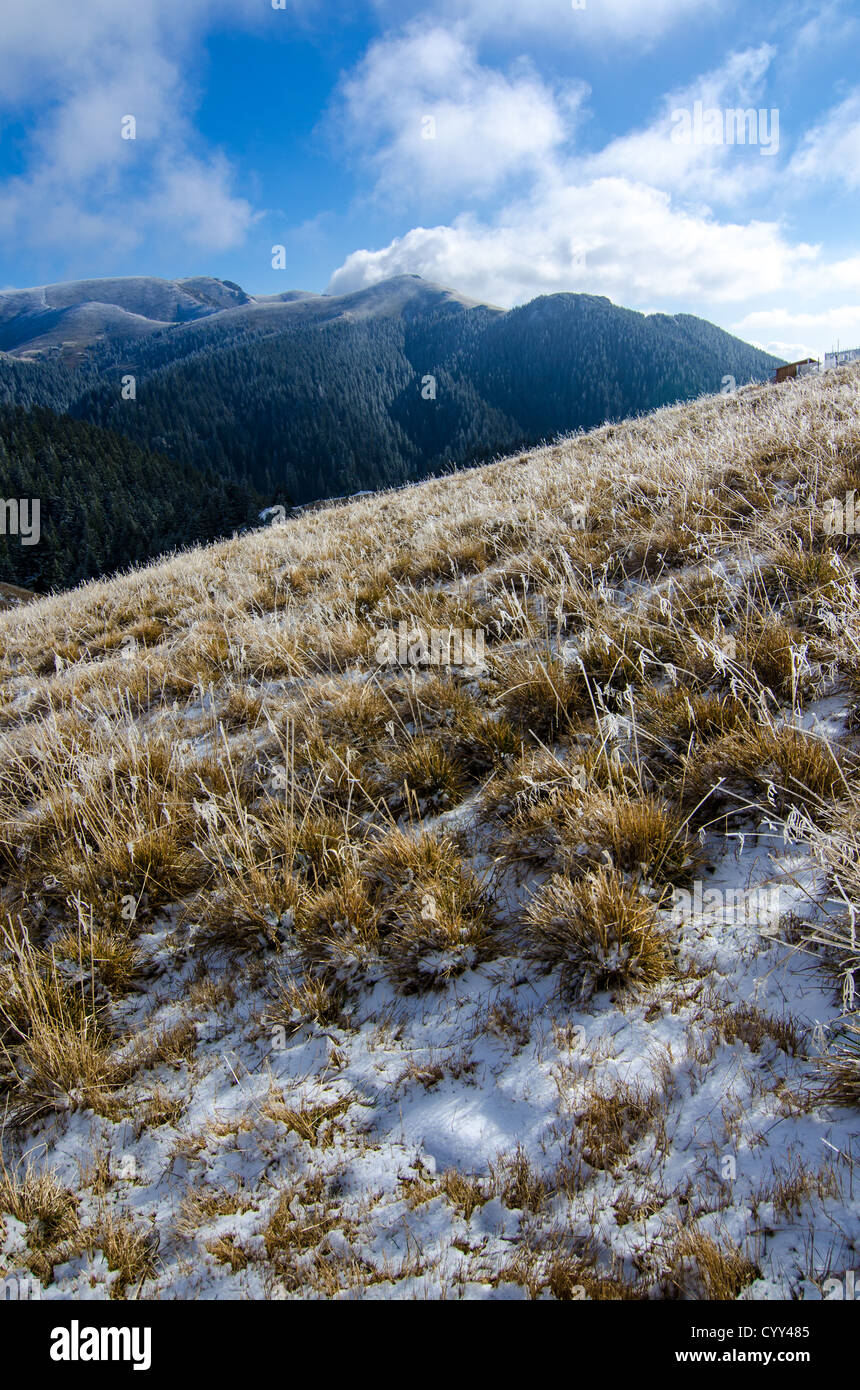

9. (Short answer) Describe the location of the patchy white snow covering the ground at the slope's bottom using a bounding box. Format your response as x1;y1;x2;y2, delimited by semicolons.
3;756;860;1298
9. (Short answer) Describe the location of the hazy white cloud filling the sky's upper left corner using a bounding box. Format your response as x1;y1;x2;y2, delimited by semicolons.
0;0;265;256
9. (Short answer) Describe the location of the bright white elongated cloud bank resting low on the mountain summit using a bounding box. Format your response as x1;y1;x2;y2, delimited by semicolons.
329;179;817;304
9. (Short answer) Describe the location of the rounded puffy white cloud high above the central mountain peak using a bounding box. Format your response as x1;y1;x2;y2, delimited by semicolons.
338;28;586;200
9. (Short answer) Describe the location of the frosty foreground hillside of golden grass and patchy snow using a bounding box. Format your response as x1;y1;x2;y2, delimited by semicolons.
0;368;860;1300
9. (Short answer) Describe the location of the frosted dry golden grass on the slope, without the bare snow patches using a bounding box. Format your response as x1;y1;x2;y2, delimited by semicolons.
0;358;860;1298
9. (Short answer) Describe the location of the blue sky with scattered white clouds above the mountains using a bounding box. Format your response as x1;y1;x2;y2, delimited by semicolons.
0;0;860;356
